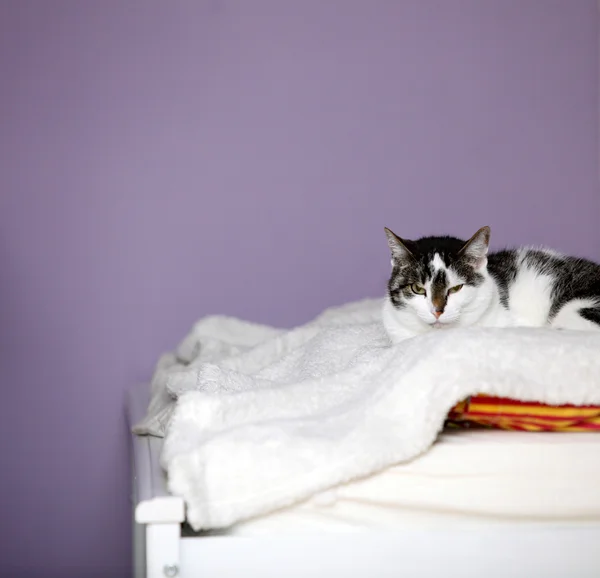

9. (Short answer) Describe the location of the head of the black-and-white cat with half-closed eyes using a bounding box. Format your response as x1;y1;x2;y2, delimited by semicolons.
385;227;490;327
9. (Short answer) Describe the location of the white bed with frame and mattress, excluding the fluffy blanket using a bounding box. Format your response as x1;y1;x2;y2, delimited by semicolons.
127;385;600;578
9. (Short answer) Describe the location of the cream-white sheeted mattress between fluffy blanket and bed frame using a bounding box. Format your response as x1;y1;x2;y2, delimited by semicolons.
227;430;600;536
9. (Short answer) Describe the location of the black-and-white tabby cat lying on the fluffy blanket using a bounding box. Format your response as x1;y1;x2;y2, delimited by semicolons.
383;227;600;342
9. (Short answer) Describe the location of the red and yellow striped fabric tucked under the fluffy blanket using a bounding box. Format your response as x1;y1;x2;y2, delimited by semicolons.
447;395;600;432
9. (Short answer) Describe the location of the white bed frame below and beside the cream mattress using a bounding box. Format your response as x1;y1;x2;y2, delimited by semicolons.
128;386;600;578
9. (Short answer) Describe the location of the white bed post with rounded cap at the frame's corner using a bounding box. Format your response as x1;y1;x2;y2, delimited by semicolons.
135;496;185;578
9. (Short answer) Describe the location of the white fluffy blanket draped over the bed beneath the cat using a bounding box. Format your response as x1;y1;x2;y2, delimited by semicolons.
134;300;600;530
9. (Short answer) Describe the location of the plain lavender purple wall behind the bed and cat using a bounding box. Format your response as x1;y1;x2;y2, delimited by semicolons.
0;0;600;578
